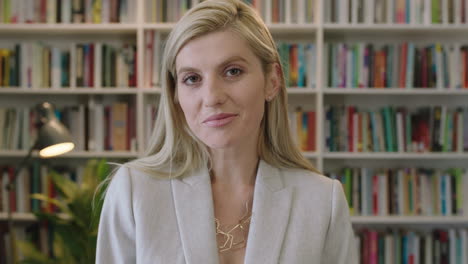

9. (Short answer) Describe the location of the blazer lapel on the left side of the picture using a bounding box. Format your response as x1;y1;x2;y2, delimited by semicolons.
172;167;219;264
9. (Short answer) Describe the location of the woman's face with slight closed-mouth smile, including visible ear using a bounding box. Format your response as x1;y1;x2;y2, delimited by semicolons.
176;31;275;149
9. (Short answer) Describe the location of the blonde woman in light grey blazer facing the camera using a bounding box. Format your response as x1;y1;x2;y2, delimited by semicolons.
97;0;357;264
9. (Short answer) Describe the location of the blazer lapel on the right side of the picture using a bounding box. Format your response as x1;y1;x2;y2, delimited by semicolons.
245;160;293;264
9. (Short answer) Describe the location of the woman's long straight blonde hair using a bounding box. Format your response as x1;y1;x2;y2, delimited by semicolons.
126;0;317;178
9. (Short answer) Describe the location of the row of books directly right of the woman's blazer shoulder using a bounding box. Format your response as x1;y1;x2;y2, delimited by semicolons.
327;168;468;216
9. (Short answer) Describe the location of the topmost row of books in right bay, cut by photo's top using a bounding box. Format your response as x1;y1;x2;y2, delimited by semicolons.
324;0;468;25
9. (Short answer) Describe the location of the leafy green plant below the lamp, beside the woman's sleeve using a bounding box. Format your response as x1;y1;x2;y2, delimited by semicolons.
17;160;109;264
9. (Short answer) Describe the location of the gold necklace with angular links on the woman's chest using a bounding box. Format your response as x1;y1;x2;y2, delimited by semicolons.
215;201;252;252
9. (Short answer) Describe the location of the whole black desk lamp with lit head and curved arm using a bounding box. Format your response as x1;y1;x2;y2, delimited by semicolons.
6;102;75;263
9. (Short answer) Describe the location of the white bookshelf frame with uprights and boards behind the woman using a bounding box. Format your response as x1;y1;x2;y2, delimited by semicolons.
0;0;468;260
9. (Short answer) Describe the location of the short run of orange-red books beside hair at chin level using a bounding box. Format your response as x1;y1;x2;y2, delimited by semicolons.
288;108;316;151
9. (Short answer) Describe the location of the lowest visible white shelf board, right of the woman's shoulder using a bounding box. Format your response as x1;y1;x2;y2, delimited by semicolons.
351;216;468;225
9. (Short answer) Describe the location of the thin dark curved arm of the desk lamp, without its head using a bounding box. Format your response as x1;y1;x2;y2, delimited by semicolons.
6;140;38;263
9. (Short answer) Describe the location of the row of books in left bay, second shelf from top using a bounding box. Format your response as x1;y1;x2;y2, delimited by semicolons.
0;42;137;89
